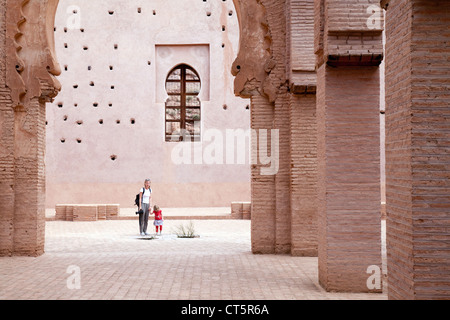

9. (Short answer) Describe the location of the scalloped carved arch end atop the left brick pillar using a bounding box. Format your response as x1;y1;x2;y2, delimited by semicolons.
6;0;61;109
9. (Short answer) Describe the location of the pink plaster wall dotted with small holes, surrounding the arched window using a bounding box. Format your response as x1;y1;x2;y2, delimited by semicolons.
46;0;250;207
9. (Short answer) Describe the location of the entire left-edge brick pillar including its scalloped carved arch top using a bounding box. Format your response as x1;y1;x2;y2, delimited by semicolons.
0;0;60;256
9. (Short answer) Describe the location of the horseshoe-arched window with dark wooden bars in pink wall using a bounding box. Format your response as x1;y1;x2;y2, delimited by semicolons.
165;64;201;141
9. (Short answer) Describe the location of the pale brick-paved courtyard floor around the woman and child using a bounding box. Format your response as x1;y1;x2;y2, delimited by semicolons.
0;215;386;300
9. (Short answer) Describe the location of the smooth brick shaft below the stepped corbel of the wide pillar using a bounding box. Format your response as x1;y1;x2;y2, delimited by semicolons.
317;64;381;292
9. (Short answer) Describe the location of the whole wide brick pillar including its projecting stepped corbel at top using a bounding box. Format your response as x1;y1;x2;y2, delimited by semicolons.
315;0;383;292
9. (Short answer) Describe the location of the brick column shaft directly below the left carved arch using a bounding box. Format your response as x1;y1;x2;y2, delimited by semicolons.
14;99;45;256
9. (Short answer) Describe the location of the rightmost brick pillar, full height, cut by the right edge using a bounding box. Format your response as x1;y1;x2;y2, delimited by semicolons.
381;0;450;299
